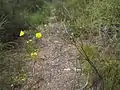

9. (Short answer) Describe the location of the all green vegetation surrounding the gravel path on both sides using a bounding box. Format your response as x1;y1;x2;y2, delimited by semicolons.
0;0;120;90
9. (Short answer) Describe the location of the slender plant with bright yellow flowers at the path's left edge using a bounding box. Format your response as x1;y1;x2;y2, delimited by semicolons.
19;30;42;59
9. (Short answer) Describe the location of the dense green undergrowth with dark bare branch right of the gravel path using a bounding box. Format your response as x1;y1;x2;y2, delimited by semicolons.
56;0;120;90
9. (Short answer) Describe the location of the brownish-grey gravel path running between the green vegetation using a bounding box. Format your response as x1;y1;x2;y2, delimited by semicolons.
24;23;85;90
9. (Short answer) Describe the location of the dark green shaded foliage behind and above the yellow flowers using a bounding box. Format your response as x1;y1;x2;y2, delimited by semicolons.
0;0;49;42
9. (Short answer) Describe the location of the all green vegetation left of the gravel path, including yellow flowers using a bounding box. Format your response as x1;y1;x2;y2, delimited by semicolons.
0;0;51;90
